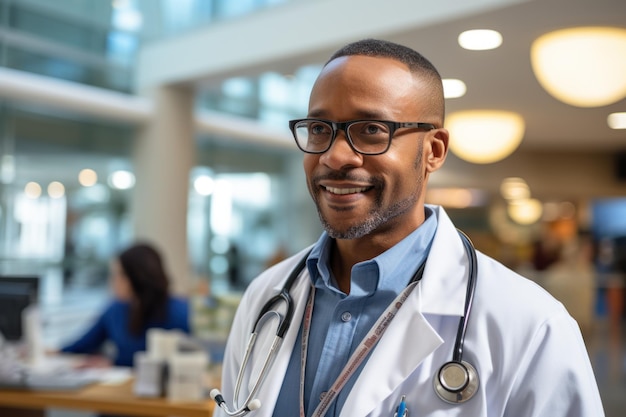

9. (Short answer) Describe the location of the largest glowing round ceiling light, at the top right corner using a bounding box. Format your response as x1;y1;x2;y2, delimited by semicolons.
530;27;626;107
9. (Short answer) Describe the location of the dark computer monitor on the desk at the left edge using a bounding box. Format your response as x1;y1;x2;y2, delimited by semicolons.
0;275;39;341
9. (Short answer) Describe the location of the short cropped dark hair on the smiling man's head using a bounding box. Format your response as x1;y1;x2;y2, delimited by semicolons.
324;39;445;123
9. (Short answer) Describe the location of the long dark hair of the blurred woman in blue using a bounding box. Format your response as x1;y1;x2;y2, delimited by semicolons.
118;243;169;335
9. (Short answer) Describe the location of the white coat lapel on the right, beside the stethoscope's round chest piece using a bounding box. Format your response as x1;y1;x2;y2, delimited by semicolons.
343;209;468;417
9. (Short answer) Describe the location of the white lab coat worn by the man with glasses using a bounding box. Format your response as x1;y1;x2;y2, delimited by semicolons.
215;207;604;417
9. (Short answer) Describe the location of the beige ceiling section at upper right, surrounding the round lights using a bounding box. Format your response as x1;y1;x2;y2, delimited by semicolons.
386;0;626;152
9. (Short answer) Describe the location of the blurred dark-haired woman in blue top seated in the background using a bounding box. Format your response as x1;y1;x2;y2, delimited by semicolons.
61;243;190;367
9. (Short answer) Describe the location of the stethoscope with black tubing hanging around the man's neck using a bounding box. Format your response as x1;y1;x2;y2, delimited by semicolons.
210;230;479;417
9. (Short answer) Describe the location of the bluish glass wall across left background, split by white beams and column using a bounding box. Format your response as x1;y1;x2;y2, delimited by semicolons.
0;0;311;300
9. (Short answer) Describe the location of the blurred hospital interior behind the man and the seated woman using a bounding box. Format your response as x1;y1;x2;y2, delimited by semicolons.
0;0;626;417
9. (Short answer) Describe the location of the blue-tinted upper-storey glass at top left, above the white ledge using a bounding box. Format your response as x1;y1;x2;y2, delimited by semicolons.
0;0;293;92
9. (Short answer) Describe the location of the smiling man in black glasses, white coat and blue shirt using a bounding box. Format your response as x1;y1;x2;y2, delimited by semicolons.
212;39;603;417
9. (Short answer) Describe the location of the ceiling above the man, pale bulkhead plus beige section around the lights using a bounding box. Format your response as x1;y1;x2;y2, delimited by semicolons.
145;0;626;152
